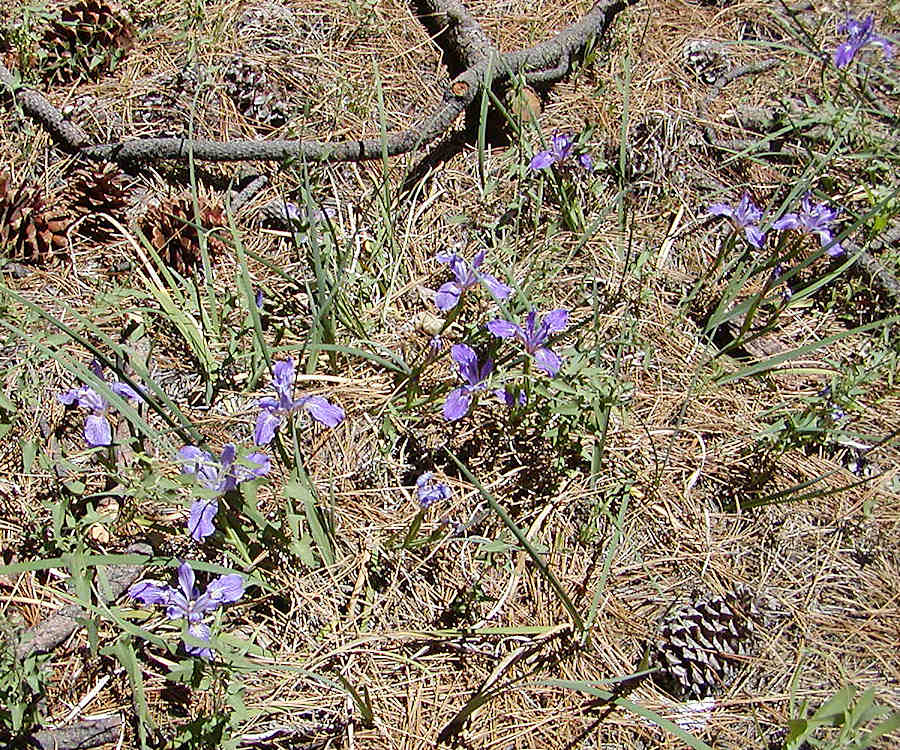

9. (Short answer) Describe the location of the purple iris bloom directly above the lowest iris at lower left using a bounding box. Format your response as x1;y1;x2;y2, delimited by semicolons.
178;443;270;542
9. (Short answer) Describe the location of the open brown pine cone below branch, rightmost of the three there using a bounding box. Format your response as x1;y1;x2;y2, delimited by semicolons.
139;196;226;276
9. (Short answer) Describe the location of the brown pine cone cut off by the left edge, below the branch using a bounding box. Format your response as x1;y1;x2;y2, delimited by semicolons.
0;174;69;264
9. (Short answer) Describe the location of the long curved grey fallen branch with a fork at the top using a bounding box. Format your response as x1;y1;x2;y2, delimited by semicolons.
0;0;637;166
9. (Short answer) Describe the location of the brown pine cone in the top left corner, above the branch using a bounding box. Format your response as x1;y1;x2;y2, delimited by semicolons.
41;0;135;83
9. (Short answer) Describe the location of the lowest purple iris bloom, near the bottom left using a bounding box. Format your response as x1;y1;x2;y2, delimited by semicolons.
128;562;244;659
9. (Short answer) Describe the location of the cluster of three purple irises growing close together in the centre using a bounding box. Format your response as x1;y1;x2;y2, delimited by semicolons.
435;250;568;422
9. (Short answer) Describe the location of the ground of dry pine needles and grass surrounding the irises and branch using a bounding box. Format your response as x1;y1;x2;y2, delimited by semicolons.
0;0;900;750
